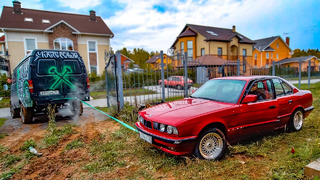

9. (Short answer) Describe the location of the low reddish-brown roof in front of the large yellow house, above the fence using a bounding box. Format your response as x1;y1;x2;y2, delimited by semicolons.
180;54;237;67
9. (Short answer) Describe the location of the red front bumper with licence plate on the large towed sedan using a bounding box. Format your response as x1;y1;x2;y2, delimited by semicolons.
136;122;197;156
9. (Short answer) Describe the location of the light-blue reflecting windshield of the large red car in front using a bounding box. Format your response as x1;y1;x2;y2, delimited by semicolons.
191;79;246;104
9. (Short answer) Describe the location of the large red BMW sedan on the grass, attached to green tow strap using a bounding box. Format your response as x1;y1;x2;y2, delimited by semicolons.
136;76;314;160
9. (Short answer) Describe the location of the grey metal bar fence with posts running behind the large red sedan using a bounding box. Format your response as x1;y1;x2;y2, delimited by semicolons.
106;51;320;109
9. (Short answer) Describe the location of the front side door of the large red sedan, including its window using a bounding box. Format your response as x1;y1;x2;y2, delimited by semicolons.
238;79;279;138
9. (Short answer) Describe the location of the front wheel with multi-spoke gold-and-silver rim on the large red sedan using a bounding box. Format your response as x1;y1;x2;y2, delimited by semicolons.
194;128;227;160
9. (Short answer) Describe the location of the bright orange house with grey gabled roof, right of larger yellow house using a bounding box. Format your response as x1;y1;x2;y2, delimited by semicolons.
249;36;292;68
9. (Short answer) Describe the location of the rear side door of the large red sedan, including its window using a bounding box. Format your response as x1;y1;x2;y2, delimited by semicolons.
272;78;295;128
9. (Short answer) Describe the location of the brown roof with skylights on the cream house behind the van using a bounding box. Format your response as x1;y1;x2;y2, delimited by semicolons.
0;6;114;37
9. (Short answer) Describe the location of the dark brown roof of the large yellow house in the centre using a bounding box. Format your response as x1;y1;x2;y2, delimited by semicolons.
171;24;255;47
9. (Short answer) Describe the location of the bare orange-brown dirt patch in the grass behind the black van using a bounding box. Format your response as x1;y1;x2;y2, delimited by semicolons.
0;109;120;179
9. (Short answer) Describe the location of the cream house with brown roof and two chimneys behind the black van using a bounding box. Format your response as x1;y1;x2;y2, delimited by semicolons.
0;0;114;75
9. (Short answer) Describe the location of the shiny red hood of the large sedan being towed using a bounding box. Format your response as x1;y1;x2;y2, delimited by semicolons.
140;98;234;125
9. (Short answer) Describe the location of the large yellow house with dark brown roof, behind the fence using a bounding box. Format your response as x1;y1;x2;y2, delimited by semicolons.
171;24;255;69
